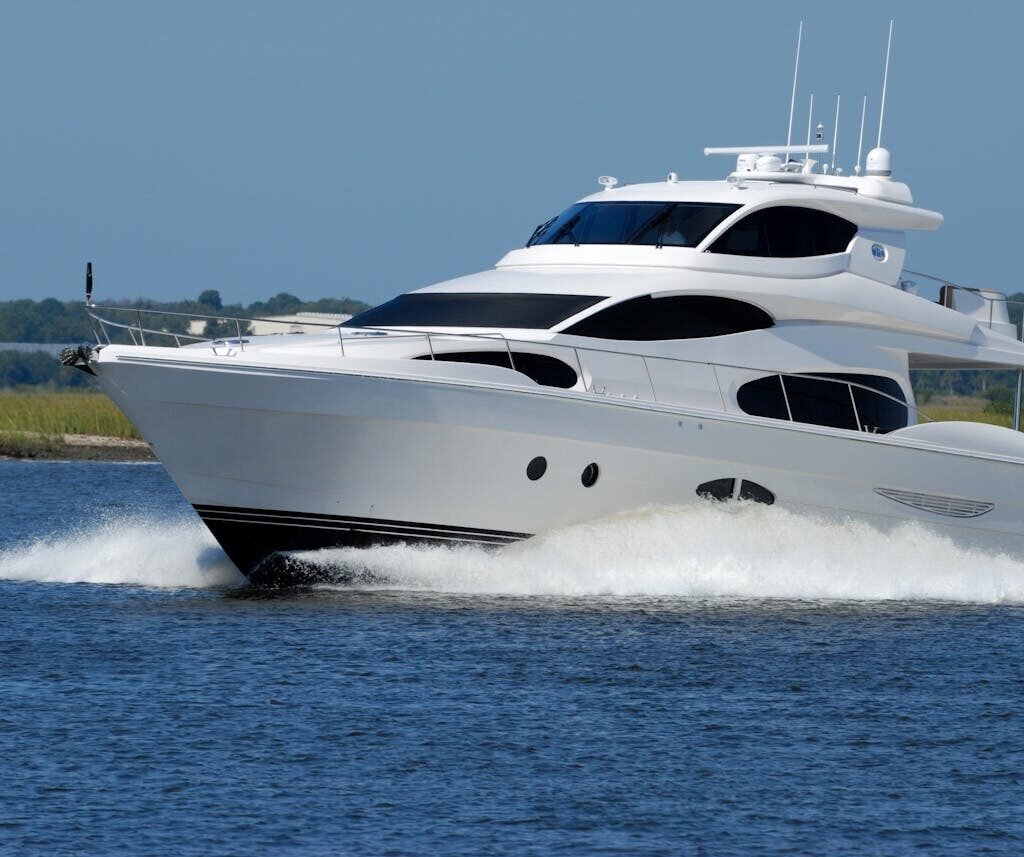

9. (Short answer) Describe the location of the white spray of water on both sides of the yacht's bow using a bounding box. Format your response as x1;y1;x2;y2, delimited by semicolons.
0;504;1024;603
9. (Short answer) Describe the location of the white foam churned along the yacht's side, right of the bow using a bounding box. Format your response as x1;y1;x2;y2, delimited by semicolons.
303;503;1024;603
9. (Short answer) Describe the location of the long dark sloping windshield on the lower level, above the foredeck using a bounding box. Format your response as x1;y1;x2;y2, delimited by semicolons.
345;292;604;330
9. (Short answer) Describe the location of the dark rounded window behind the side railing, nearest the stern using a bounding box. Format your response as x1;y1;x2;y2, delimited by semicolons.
737;373;907;432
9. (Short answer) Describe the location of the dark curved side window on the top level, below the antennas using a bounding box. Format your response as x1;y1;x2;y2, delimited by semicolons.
709;206;857;258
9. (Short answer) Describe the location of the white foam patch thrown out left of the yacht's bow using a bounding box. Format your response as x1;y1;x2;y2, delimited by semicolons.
0;519;244;589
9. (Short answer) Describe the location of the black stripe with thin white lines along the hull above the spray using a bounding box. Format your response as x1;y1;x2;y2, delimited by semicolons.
195;505;530;545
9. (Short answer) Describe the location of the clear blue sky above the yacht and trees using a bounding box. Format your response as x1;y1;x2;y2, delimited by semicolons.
0;0;1024;303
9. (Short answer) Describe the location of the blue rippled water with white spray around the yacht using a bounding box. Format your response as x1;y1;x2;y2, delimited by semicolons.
0;462;1024;855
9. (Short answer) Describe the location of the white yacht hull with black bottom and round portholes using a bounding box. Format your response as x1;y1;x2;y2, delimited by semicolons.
95;347;1024;582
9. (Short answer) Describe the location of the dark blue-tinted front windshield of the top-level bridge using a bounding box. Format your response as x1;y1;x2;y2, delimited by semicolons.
526;202;739;247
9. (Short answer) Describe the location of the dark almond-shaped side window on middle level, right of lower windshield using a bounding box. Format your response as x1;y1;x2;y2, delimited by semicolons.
564;295;772;340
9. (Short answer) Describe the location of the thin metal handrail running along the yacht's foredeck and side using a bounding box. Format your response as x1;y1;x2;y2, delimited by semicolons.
86;306;932;431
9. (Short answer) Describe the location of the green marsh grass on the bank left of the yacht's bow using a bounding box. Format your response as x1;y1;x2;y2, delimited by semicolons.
0;392;139;443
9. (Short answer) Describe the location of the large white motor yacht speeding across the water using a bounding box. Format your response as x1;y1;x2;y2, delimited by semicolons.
74;139;1024;581
